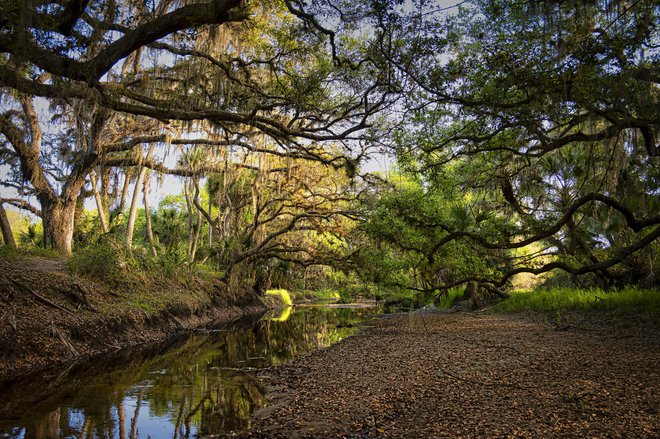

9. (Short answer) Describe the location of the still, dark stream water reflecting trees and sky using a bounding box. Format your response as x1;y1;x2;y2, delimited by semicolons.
0;307;377;439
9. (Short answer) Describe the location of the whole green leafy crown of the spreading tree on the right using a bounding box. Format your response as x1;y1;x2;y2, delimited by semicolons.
358;0;660;291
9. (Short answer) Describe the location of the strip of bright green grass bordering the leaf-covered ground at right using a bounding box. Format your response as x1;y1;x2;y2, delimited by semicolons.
493;288;660;316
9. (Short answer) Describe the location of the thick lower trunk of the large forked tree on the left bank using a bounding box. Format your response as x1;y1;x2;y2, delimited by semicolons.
41;199;76;255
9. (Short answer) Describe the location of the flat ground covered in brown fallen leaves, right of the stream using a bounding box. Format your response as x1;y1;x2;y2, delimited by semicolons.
242;310;660;438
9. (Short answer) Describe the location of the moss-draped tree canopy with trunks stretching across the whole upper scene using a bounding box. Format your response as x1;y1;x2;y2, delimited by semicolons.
0;0;660;294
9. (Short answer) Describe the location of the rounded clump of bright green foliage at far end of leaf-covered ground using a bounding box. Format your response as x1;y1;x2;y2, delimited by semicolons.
358;173;508;291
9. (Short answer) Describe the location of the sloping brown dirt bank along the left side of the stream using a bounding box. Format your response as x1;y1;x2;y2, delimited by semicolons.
0;257;266;380
